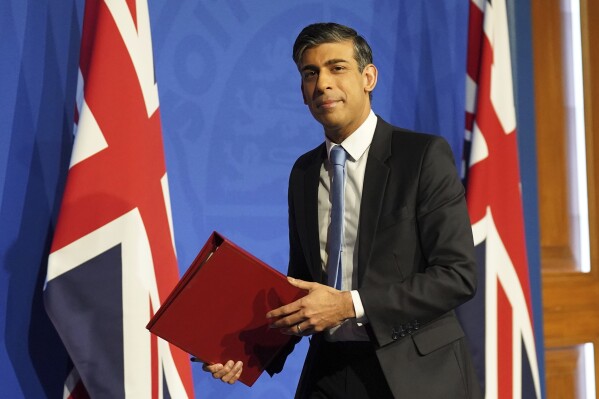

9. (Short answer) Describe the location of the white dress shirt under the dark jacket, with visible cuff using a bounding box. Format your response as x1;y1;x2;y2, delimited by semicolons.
318;110;377;341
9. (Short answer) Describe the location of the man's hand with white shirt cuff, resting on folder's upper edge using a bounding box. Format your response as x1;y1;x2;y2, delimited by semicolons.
266;277;356;336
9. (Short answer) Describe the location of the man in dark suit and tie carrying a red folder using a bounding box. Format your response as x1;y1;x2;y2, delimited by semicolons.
204;23;481;399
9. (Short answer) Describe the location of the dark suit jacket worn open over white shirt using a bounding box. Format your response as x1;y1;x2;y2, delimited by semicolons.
268;117;484;399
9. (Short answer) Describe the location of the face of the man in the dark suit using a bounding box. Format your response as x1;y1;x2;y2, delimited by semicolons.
299;40;377;143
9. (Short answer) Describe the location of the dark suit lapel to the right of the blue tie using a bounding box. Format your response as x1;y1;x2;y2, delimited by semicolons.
358;118;393;285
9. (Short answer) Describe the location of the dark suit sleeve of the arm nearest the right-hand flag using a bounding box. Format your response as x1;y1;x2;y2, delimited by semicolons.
358;136;476;346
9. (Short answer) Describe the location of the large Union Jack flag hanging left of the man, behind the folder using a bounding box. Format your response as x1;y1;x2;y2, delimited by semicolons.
44;0;193;398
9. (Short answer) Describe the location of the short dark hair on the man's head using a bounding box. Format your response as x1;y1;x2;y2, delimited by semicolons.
293;22;372;72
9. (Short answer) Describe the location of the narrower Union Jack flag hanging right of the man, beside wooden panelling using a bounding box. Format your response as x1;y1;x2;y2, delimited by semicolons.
461;0;541;399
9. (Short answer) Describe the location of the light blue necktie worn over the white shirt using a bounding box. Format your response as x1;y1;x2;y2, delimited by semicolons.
327;145;347;290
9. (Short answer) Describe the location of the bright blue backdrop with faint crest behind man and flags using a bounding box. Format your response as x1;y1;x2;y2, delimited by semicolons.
0;0;541;398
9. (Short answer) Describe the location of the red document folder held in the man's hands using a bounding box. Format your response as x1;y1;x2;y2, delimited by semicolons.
147;232;306;386
